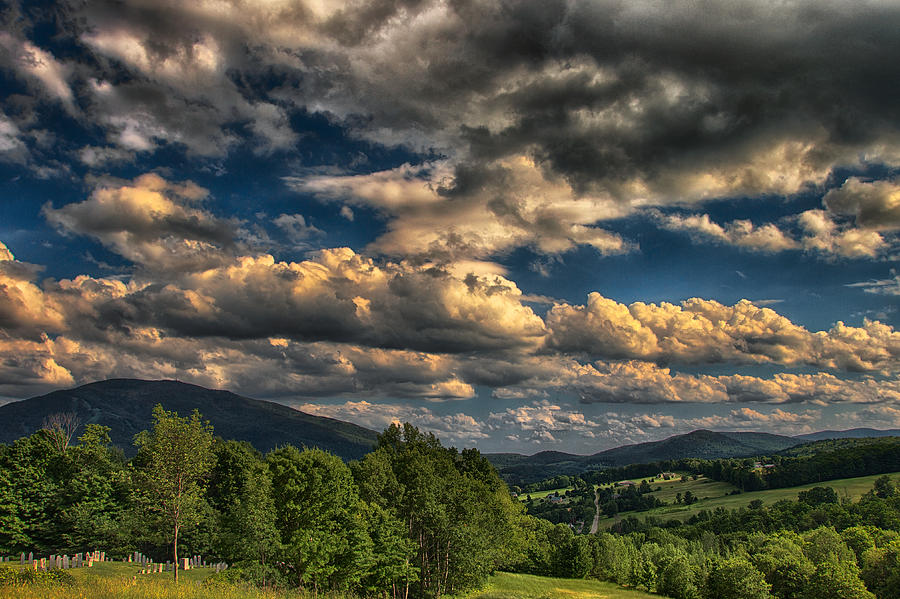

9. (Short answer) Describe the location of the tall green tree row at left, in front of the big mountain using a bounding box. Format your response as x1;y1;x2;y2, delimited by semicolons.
0;406;527;598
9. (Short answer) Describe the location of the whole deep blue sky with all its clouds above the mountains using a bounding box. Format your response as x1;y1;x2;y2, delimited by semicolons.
0;0;900;453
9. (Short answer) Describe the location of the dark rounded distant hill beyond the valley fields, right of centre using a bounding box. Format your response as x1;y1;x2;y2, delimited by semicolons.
486;430;804;484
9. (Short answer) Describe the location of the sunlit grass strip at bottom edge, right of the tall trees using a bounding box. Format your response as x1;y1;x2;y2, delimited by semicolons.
460;572;662;599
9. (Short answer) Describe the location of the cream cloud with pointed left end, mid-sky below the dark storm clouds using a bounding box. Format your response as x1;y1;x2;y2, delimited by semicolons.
286;156;633;260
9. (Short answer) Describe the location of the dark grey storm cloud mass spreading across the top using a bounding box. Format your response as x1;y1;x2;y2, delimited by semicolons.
7;0;900;211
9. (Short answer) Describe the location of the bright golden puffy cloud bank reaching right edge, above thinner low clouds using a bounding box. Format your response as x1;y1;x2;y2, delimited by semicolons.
546;293;900;372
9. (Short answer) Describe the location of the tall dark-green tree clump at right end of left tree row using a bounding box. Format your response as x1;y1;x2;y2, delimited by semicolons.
354;424;525;597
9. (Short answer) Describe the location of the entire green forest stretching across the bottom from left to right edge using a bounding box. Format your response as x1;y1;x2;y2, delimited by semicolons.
0;407;900;599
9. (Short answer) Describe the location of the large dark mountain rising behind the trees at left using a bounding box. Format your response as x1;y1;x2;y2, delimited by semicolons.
0;379;376;460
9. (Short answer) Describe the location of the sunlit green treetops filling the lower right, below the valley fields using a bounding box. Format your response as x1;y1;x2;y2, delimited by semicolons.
517;476;900;599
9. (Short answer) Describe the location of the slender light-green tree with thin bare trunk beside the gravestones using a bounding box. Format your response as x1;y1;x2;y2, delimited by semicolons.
134;404;214;582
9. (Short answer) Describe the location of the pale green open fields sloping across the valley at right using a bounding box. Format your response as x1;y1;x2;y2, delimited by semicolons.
600;472;900;530
